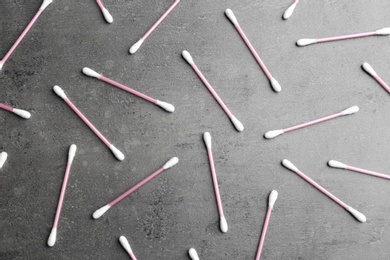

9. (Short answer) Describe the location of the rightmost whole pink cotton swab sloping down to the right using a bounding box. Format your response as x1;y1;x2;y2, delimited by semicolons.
282;159;367;222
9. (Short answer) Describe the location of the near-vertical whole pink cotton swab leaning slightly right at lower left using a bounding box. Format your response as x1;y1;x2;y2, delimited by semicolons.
47;144;77;247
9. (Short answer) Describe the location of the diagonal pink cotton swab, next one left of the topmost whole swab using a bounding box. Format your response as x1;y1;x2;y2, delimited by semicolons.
182;51;244;132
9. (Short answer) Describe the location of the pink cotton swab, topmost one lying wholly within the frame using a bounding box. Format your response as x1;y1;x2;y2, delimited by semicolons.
225;9;282;92
